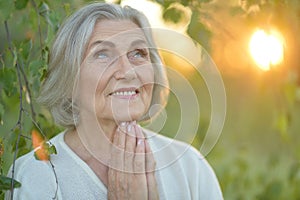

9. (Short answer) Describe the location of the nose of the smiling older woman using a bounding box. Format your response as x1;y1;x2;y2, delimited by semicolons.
114;55;137;80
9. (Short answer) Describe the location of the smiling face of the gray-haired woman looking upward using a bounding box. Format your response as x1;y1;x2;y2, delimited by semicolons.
77;20;154;122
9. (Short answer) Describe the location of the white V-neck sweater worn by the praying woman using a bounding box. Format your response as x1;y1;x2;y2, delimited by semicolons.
6;130;223;200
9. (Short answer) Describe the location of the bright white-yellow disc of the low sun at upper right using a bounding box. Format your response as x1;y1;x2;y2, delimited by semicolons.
249;30;284;71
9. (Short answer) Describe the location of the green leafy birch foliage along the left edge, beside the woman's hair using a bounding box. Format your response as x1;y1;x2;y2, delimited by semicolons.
0;0;67;199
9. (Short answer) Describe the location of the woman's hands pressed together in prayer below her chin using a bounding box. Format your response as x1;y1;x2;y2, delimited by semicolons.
108;122;159;200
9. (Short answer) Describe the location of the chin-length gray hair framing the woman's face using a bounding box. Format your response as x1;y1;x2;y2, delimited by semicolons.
38;3;169;128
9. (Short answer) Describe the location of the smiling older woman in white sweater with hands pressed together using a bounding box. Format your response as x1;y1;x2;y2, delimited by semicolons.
6;3;222;200
